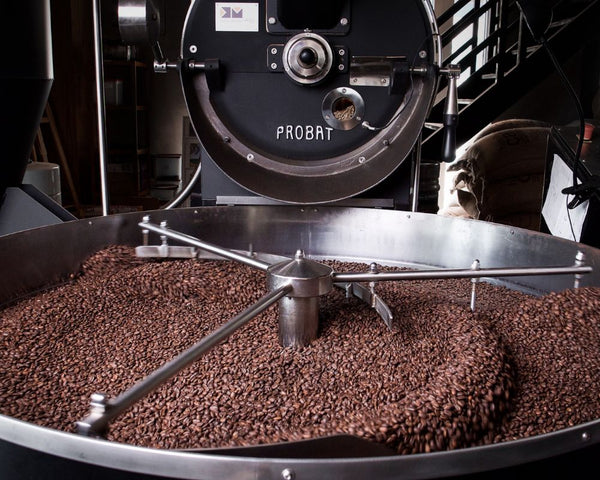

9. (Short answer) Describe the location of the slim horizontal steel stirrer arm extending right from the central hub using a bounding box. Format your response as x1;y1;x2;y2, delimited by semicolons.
333;266;593;282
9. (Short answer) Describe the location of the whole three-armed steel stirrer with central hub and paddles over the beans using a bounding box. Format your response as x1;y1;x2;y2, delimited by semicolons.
77;217;592;437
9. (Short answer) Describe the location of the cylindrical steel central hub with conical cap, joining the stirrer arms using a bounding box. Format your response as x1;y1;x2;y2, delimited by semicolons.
267;250;333;347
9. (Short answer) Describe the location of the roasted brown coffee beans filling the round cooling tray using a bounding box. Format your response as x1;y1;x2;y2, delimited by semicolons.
0;246;600;453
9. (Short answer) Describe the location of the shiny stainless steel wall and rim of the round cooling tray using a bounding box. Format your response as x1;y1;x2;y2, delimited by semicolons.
0;207;600;479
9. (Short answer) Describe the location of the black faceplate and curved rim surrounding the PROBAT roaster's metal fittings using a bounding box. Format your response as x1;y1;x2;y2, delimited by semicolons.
182;0;437;203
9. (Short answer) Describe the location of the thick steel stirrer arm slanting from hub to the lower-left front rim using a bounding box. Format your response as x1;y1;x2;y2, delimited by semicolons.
77;285;292;436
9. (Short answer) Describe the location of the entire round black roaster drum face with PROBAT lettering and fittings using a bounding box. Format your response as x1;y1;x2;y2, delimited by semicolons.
181;0;439;203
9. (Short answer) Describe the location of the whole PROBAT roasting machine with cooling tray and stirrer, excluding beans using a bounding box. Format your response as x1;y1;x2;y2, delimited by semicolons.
0;0;600;480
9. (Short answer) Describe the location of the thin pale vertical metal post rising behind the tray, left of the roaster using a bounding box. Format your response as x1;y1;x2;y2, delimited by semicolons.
92;0;110;216
